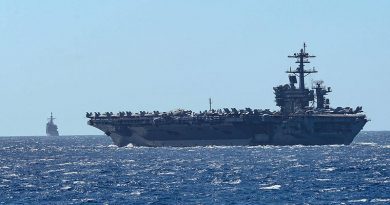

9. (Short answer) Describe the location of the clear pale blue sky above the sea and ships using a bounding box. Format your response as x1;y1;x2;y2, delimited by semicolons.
0;0;390;136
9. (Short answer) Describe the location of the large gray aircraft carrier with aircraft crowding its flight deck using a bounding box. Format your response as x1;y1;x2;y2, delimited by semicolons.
86;44;367;147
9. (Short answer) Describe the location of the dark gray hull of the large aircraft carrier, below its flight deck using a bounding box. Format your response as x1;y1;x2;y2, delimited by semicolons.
89;114;367;147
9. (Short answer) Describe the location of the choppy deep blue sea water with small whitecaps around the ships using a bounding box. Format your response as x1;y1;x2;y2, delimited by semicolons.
0;132;390;204
